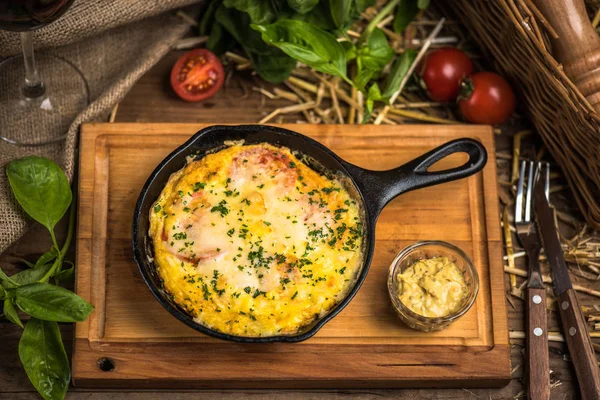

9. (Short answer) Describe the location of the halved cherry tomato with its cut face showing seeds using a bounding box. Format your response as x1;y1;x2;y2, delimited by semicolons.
171;49;225;101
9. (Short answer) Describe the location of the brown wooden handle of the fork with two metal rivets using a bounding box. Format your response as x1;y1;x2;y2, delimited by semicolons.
527;288;550;400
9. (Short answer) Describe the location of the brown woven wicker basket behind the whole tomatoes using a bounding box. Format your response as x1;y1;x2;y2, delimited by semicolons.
442;0;600;229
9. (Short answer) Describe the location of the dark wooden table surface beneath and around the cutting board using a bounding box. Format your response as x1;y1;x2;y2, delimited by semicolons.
0;52;598;400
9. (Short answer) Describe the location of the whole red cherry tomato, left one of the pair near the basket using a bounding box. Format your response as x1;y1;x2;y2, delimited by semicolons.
420;47;473;101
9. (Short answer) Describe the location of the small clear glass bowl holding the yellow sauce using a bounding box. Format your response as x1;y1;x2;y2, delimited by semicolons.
388;241;479;332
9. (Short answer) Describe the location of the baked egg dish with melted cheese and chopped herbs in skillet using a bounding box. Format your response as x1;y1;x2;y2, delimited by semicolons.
149;143;363;337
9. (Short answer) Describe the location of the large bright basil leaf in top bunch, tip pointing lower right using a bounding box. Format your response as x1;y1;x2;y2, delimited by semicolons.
252;20;348;79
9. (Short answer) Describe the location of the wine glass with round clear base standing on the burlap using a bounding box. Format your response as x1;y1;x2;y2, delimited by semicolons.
0;0;89;146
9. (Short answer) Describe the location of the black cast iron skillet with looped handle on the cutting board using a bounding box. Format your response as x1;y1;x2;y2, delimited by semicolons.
133;125;487;343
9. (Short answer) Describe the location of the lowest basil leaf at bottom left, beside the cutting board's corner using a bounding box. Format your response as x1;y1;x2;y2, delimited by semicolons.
19;318;71;400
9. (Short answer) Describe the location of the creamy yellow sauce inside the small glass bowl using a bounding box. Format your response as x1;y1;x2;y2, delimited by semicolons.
398;257;467;318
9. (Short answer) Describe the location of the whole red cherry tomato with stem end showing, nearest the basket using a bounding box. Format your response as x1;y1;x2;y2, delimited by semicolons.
458;72;516;125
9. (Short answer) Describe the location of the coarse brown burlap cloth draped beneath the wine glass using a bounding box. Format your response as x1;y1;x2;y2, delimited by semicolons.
0;0;204;253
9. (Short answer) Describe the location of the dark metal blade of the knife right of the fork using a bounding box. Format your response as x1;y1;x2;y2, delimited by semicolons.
534;179;573;296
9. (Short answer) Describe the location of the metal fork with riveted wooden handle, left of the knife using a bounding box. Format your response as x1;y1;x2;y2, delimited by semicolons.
515;161;550;400
